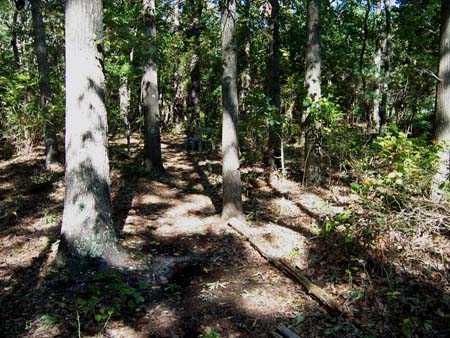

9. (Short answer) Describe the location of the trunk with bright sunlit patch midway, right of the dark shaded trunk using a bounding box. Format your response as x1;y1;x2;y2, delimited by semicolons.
303;0;323;186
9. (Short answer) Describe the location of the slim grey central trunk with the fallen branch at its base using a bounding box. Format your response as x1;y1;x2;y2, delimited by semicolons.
221;0;244;220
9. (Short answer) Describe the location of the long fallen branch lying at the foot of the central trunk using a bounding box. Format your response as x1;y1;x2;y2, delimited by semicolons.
227;218;343;314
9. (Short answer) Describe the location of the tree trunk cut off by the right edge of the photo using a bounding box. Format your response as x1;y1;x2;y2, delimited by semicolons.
432;1;450;200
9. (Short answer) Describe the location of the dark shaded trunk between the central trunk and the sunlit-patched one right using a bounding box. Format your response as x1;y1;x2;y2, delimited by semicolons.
266;0;282;174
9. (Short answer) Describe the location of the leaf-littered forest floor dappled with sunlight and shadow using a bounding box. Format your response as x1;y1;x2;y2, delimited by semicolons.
0;133;450;338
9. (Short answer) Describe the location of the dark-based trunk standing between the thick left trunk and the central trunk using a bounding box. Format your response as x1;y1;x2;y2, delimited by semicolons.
141;0;164;172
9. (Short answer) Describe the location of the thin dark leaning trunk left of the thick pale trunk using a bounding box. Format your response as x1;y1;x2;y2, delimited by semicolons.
30;0;59;167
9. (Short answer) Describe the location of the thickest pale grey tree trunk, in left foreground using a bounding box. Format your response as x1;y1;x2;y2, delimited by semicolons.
60;0;123;269
